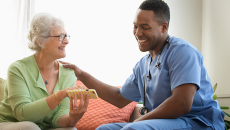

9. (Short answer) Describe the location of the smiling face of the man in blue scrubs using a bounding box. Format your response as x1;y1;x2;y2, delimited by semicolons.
133;9;163;52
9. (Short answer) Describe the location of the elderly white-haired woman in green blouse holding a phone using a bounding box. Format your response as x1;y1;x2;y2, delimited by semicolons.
0;13;89;130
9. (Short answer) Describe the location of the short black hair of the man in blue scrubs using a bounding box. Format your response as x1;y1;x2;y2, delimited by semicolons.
139;0;170;25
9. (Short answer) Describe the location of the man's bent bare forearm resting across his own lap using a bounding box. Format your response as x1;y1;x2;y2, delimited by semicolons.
134;84;197;122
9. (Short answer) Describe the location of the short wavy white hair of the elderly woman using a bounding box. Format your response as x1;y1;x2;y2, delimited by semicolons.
27;13;64;52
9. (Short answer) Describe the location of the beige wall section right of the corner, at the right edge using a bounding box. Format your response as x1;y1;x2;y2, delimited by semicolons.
202;0;230;97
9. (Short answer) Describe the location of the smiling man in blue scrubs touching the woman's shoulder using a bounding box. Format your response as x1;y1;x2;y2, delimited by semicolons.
61;0;224;130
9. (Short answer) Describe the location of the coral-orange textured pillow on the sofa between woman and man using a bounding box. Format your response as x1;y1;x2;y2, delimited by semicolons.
75;81;137;130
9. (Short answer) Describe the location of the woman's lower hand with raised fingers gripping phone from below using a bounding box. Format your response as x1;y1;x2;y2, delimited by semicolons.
69;93;89;126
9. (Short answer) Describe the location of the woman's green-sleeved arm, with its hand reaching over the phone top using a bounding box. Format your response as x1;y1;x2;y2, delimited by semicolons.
7;62;83;122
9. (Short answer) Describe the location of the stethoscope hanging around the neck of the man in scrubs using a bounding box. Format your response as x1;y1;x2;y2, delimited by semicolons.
139;36;170;115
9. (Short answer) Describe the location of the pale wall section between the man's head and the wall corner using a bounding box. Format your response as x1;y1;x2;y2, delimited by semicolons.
166;0;202;51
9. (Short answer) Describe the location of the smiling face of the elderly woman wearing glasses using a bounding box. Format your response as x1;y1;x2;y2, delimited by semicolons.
41;27;69;59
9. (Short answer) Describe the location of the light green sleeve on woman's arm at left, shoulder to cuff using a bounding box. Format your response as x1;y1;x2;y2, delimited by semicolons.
7;62;51;122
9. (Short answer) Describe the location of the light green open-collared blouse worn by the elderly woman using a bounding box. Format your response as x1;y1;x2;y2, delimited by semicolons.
0;55;77;129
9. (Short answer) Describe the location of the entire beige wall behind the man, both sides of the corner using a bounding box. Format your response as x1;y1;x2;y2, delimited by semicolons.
166;0;230;119
